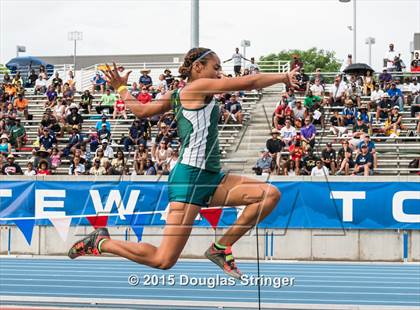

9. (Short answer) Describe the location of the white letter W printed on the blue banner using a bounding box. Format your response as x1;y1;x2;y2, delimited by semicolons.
89;189;140;220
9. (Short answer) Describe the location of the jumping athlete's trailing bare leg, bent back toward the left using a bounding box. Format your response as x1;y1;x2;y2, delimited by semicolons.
101;202;200;269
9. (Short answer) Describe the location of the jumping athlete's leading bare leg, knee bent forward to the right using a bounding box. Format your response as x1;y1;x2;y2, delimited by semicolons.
210;175;281;246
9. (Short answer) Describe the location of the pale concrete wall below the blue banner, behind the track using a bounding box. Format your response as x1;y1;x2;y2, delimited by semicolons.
0;226;420;262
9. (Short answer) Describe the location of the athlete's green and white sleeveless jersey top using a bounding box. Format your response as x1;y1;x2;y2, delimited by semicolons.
172;89;220;172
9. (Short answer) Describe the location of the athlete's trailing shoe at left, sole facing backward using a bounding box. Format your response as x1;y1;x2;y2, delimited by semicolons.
68;228;110;259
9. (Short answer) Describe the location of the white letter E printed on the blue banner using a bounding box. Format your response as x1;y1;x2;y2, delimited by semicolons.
35;189;66;218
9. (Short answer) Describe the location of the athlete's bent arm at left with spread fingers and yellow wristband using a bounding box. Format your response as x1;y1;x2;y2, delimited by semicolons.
104;63;172;117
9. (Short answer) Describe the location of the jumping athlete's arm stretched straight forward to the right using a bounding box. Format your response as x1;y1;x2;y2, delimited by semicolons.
185;68;299;93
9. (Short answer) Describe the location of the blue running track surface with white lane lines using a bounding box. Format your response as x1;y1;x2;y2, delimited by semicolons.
0;257;420;309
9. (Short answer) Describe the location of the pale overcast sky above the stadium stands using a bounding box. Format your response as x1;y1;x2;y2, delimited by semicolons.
0;0;420;70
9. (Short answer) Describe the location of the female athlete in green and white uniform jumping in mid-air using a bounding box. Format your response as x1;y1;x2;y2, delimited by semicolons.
69;48;298;279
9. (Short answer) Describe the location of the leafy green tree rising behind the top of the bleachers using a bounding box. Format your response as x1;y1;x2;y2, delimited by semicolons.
260;47;341;72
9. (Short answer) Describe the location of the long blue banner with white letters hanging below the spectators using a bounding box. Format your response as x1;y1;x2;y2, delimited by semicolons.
0;181;420;229
